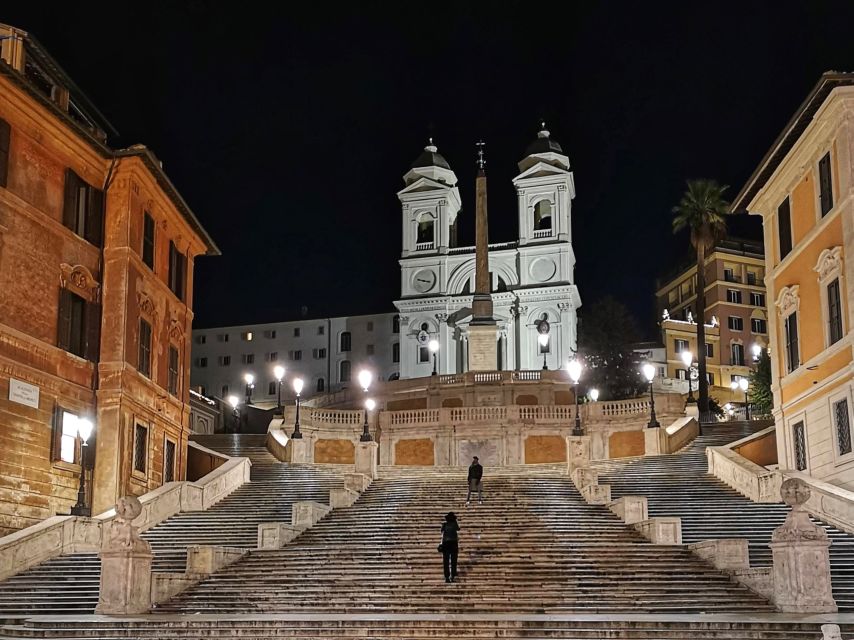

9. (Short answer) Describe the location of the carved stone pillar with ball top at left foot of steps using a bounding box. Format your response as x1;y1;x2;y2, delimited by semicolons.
95;496;153;615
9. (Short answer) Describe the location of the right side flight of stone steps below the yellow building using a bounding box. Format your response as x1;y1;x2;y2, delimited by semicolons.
592;423;854;612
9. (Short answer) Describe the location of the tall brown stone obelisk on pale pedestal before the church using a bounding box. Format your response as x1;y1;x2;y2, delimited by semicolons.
468;141;498;371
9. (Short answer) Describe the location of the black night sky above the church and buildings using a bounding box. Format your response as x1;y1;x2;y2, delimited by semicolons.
6;0;854;336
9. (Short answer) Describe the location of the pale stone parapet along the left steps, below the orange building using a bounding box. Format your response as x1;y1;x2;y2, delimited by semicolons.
0;450;251;580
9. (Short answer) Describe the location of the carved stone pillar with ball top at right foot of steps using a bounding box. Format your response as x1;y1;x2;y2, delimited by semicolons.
769;478;837;613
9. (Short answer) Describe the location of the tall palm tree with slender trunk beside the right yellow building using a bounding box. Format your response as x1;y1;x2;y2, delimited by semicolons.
673;179;729;415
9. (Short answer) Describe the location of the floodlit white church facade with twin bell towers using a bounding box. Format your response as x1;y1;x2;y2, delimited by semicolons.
395;126;581;378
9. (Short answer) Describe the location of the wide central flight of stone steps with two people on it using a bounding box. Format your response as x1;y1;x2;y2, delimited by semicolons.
157;466;772;616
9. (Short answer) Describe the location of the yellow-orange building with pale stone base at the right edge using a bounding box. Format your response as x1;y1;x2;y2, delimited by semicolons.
733;73;854;489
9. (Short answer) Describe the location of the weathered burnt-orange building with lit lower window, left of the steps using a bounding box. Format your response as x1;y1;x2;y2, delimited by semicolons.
0;25;218;534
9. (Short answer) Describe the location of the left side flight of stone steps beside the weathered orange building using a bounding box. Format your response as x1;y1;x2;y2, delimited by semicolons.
0;435;342;620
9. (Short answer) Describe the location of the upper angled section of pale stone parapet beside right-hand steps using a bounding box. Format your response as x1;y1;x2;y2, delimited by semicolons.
706;427;783;502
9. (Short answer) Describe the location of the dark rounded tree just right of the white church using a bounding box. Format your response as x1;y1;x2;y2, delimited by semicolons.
579;296;646;400
